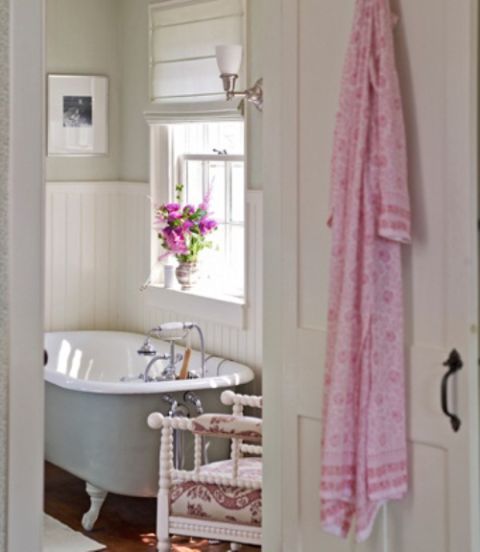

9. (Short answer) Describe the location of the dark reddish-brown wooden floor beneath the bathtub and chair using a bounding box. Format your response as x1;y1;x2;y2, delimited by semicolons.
45;464;260;552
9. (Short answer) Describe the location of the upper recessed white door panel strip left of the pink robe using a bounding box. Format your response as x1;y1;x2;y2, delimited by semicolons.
297;0;348;330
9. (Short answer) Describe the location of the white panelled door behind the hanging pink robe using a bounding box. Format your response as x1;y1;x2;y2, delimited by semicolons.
264;0;480;552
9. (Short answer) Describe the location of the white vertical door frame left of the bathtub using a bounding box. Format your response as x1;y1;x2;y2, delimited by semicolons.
6;0;45;552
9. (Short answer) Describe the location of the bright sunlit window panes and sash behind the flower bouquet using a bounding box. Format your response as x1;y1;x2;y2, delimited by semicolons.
165;122;245;298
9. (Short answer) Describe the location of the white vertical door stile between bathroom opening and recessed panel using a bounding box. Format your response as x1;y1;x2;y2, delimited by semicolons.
262;0;292;552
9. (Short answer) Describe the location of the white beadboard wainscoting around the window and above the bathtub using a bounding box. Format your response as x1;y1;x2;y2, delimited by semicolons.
45;182;263;382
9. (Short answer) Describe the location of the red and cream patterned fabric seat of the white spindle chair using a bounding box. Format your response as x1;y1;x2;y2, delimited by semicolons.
170;457;262;526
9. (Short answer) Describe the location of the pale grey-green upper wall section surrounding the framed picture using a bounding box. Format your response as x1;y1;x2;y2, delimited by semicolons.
46;0;121;181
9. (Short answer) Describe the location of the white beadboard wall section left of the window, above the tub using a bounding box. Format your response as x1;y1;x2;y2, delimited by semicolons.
45;181;150;330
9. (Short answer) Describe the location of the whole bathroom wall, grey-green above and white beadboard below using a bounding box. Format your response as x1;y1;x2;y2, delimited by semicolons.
45;0;262;380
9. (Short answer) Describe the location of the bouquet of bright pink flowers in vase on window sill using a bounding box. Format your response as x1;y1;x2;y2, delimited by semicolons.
155;185;218;263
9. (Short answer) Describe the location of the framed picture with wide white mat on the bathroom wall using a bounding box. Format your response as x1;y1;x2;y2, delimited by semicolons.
48;75;108;156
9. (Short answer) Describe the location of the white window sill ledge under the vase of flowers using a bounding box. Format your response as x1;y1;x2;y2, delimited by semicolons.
145;284;246;329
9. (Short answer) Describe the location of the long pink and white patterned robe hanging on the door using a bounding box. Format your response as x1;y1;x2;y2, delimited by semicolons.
320;0;410;541
